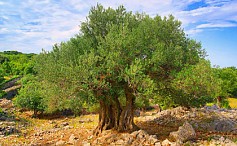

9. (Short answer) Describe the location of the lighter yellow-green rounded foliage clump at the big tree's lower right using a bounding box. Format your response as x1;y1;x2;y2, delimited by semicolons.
173;60;221;107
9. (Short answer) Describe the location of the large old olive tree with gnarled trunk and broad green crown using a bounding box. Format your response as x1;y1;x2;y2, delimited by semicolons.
36;5;215;134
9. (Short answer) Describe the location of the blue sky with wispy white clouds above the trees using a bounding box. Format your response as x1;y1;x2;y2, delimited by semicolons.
0;0;237;67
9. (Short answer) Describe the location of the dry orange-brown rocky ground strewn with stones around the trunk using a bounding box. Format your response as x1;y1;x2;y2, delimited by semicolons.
0;99;237;146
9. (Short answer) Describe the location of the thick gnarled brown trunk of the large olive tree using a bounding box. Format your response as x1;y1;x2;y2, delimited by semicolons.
94;87;138;135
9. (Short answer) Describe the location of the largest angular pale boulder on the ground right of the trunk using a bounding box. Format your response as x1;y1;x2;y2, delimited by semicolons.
170;122;196;142
